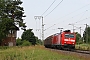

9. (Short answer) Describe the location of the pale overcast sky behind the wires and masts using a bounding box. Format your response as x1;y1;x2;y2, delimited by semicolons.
17;0;90;38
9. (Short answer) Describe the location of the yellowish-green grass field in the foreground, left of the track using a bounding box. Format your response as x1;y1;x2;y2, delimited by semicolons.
0;46;80;60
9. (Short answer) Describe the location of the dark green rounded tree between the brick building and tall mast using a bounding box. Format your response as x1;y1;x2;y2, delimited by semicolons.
21;29;36;45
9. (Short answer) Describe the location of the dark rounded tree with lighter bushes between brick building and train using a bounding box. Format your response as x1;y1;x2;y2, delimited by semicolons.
16;29;43;46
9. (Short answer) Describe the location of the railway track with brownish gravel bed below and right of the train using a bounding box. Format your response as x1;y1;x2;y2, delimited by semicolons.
46;48;90;60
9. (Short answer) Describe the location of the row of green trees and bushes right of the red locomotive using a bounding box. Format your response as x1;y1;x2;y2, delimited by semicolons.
76;26;90;44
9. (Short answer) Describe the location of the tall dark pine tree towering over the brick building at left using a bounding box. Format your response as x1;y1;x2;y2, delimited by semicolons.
0;0;26;41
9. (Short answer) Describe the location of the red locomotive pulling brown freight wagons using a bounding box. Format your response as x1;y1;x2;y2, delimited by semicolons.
44;30;76;49
